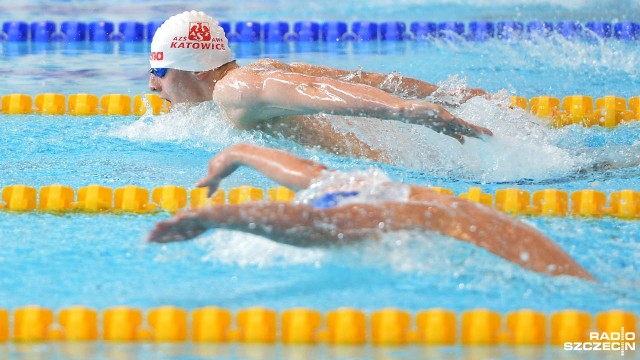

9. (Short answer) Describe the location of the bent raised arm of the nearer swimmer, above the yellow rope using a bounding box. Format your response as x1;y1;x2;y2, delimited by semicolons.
197;144;327;195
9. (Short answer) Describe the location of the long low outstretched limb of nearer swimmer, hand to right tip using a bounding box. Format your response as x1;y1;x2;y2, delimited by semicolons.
149;198;593;280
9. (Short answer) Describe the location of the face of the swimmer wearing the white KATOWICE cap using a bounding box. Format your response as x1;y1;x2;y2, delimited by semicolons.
149;69;204;104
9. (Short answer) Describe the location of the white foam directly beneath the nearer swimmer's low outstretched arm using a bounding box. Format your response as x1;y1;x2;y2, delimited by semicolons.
196;230;552;288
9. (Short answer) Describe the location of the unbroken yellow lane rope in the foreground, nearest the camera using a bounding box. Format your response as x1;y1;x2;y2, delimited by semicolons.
0;305;637;351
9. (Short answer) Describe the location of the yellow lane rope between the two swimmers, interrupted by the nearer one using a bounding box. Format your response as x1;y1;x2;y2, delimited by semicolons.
0;184;640;220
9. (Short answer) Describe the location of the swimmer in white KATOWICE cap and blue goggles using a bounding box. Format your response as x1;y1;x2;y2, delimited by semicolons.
149;11;492;160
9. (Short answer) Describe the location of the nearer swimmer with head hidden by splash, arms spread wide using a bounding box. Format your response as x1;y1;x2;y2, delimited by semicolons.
148;144;594;280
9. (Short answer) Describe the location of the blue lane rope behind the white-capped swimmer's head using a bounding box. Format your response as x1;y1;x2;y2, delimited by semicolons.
0;20;640;43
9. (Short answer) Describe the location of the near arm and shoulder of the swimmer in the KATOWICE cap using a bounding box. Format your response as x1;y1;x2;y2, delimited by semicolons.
234;71;491;142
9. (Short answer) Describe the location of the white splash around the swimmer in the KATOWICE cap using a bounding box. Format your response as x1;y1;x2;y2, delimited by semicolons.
110;89;640;182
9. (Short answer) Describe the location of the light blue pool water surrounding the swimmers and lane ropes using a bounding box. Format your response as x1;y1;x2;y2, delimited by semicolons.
0;1;640;358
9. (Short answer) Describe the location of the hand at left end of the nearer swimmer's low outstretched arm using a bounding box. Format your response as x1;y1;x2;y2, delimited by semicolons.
147;210;211;243
